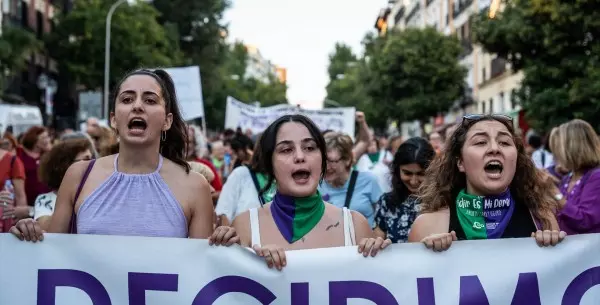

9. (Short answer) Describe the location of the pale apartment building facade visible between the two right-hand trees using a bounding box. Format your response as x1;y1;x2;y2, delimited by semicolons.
376;0;523;131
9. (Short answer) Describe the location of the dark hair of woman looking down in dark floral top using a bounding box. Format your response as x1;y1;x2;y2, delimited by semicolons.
389;137;435;211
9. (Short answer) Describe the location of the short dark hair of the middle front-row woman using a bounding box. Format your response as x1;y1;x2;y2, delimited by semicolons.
255;114;327;193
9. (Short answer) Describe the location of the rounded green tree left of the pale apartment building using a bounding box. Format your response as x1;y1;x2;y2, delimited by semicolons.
368;27;467;121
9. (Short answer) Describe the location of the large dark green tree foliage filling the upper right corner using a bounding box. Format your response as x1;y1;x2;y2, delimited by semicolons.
475;0;600;131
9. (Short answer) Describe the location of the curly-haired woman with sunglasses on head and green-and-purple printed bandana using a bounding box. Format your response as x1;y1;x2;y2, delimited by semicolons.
409;115;566;251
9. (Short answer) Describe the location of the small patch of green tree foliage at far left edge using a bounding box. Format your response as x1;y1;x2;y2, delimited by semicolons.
0;26;42;92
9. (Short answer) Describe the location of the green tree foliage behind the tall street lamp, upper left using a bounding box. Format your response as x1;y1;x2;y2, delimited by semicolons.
47;0;182;89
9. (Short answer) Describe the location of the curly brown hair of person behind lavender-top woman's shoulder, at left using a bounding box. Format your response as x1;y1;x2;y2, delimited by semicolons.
38;138;94;191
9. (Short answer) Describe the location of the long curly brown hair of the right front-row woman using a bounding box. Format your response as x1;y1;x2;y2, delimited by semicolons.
419;115;556;229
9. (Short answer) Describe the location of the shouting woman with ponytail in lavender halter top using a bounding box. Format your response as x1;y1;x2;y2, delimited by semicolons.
11;69;238;245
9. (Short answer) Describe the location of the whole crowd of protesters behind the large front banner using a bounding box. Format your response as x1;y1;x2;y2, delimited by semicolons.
0;70;600;269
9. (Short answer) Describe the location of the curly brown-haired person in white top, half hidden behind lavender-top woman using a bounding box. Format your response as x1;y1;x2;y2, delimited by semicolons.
33;138;94;230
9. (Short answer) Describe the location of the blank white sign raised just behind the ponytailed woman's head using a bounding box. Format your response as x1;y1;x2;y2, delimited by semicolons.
163;66;204;121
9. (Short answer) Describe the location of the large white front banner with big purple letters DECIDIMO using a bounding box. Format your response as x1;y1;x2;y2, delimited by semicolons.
0;234;600;305
